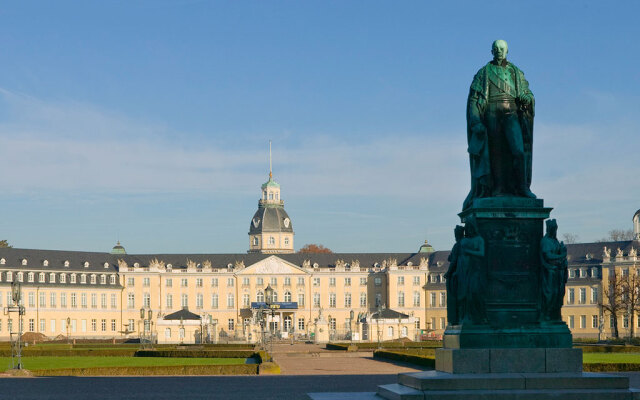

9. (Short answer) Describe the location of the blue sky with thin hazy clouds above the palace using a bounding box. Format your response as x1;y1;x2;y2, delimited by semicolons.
0;0;640;253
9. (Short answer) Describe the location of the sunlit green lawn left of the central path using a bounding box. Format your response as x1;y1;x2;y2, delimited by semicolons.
0;357;246;370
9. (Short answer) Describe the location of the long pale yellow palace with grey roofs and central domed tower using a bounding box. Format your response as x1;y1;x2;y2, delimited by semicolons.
0;163;640;343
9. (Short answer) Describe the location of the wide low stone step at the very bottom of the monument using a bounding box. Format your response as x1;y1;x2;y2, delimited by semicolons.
378;371;640;400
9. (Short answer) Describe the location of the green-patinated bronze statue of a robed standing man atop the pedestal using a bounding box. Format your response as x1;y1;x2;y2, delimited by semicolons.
463;40;536;209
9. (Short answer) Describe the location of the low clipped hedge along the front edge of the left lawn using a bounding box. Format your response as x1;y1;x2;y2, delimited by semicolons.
31;364;258;376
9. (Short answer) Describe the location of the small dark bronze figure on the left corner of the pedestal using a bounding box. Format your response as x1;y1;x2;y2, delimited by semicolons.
457;215;486;325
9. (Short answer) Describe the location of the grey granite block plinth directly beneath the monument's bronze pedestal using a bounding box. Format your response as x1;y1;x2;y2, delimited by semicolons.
436;348;582;374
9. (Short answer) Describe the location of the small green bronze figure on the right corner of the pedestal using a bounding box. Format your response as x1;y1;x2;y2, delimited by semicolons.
540;219;568;321
